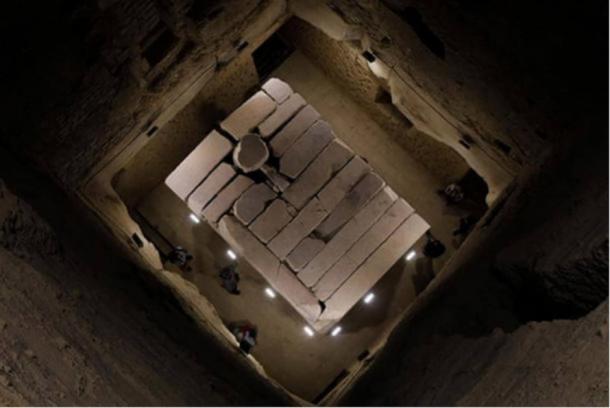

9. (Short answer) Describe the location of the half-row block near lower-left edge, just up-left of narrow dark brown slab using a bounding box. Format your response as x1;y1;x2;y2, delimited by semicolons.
269;198;327;260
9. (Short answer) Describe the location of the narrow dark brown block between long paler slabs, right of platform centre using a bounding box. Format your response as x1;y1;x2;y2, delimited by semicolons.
316;173;385;237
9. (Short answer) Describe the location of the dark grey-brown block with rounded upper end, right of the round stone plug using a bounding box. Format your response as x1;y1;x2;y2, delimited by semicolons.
279;120;334;179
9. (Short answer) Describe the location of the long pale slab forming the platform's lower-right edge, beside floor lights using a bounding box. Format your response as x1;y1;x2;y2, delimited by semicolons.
321;214;430;321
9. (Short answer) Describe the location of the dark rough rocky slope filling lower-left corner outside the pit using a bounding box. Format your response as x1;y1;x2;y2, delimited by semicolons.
0;173;290;406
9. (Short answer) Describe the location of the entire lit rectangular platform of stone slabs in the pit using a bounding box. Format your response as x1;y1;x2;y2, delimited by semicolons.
166;78;429;331
